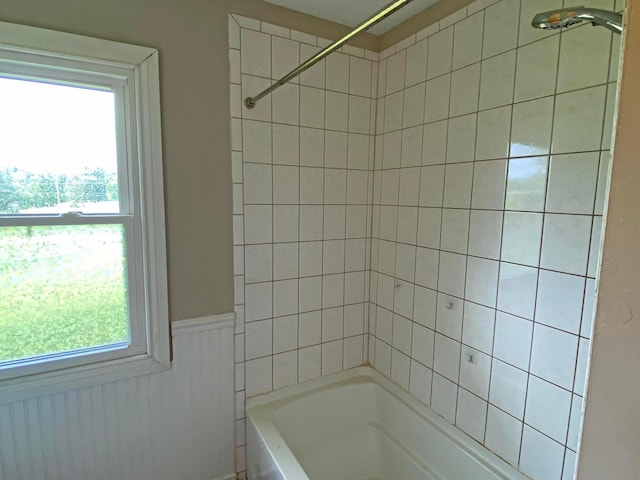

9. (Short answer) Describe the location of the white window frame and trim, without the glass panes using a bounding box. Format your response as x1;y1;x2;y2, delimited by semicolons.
0;22;171;403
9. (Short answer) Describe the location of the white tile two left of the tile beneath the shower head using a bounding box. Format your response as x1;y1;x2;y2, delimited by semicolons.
479;50;516;110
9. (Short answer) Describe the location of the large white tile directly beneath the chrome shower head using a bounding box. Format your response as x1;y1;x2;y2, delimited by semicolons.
557;22;612;92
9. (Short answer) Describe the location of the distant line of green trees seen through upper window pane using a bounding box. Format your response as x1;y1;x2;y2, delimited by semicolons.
0;167;118;214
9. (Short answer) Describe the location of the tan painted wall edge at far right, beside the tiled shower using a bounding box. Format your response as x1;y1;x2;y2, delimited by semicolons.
578;0;640;480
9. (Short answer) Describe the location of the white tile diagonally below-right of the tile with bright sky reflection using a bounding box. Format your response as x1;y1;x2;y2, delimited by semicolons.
540;215;591;275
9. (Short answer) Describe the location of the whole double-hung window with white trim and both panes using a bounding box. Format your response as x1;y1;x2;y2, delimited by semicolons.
0;22;169;397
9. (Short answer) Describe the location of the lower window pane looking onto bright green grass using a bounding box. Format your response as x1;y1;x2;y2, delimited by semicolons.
0;225;129;362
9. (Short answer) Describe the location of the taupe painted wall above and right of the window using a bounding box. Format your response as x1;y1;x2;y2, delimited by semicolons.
0;0;233;320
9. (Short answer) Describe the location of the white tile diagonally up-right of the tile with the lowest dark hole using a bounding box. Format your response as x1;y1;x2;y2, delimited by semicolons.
493;312;533;370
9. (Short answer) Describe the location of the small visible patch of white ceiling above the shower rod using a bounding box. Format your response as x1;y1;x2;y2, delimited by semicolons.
266;0;438;35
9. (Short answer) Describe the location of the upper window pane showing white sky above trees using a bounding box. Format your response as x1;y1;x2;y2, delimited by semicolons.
0;78;120;215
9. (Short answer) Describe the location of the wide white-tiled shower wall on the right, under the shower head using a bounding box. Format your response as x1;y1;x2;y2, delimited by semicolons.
369;0;621;480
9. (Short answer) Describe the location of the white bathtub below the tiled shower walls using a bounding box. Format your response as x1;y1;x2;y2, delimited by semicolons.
247;367;527;480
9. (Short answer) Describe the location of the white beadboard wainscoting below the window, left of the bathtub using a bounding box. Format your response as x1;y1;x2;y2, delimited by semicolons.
0;314;235;480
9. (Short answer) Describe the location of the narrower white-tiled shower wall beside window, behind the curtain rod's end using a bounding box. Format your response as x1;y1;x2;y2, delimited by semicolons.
229;16;378;472
